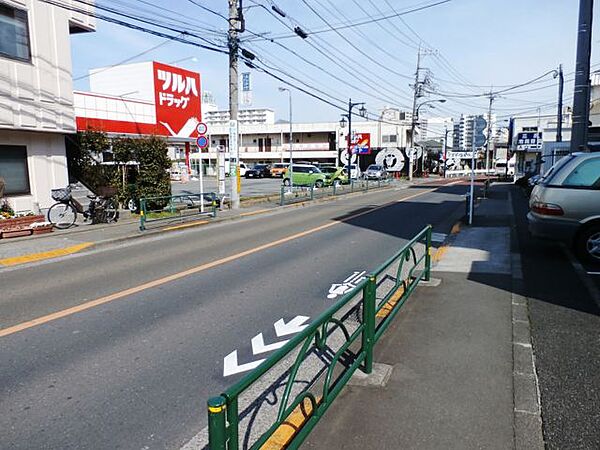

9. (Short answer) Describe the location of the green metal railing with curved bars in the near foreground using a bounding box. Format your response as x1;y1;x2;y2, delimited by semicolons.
208;226;431;450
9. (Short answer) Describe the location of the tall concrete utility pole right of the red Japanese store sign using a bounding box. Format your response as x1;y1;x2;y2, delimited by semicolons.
227;0;242;209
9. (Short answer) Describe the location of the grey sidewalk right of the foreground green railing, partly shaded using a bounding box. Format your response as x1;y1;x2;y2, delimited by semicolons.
303;187;543;450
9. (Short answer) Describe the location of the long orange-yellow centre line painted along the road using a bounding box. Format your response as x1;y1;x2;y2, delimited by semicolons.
0;184;437;337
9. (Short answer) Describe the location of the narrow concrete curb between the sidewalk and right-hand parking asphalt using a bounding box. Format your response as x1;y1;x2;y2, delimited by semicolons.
508;192;545;450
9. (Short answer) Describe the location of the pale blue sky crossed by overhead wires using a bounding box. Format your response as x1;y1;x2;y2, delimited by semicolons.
72;0;600;132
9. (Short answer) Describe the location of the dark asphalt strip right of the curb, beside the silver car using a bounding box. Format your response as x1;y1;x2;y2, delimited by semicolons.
513;189;600;449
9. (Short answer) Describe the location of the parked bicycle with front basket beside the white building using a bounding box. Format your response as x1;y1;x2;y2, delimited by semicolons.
48;186;119;230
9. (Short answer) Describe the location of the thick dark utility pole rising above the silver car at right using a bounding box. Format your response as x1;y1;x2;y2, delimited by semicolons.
571;0;594;152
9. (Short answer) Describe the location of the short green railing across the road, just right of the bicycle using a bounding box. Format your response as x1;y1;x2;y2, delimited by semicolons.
140;192;218;231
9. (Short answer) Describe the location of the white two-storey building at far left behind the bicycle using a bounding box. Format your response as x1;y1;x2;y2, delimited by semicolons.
0;0;95;211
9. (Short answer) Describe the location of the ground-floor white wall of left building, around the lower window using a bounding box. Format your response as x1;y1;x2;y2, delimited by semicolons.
0;131;69;211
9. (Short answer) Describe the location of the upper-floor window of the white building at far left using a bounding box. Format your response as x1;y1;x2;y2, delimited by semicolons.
0;4;31;61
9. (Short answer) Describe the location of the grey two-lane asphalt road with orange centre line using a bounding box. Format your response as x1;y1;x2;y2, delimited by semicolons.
0;180;465;449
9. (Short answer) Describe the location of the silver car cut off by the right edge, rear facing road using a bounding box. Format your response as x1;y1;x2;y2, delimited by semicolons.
527;153;600;262
